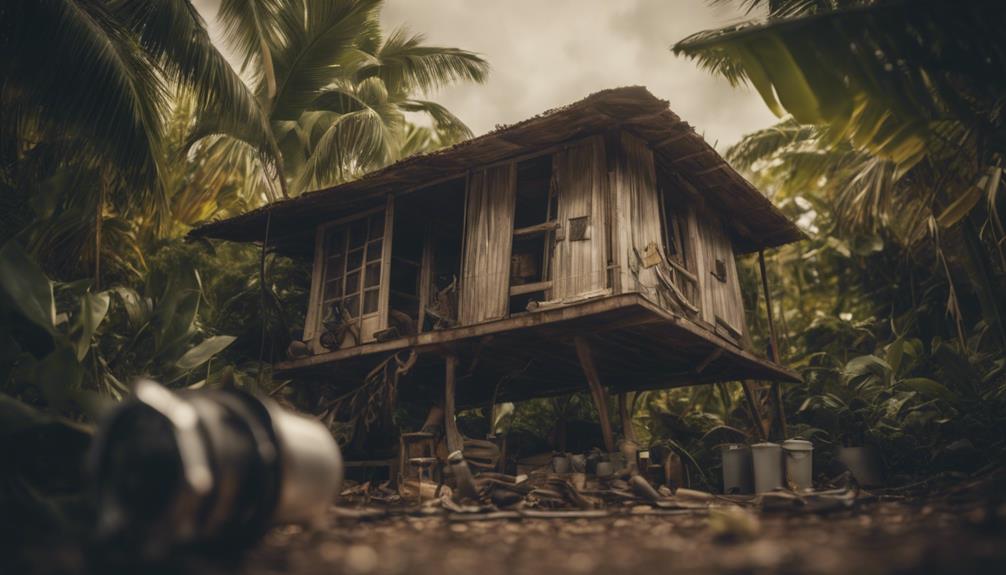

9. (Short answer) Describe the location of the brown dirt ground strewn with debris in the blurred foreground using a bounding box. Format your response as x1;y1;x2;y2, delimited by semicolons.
222;490;1006;575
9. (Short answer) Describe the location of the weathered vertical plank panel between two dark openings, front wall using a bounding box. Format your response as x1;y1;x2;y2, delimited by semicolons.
458;163;516;325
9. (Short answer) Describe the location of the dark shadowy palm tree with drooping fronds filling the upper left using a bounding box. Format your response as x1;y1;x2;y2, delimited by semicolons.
0;0;270;279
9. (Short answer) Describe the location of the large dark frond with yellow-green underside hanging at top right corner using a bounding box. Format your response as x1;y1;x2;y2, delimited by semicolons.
673;0;1006;173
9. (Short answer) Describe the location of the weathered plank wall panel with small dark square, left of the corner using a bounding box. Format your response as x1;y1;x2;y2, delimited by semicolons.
550;137;608;300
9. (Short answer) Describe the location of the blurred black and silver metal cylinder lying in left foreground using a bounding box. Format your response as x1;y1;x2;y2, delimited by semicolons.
91;380;343;557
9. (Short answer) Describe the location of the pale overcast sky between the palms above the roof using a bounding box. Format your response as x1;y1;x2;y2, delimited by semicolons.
194;0;775;150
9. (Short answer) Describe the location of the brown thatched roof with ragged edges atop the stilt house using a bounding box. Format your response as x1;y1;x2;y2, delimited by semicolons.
189;86;803;252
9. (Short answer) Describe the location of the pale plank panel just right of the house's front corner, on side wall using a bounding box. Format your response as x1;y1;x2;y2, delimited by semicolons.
616;132;662;302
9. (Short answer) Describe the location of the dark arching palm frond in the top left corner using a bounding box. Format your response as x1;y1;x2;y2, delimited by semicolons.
0;0;166;188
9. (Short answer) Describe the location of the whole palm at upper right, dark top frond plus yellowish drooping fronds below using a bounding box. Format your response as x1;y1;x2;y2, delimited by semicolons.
672;0;1006;346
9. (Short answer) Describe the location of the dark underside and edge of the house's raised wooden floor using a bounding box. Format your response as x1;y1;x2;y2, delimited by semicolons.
277;294;799;407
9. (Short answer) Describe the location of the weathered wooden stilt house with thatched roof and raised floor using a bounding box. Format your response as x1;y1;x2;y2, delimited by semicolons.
192;87;802;454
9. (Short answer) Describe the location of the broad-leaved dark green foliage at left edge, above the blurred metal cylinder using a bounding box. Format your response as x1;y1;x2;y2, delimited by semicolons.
0;242;234;415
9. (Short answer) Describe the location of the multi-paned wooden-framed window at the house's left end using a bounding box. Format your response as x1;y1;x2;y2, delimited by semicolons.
321;210;384;322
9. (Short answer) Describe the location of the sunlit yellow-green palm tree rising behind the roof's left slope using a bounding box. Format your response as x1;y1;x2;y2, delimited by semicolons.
191;0;488;194
